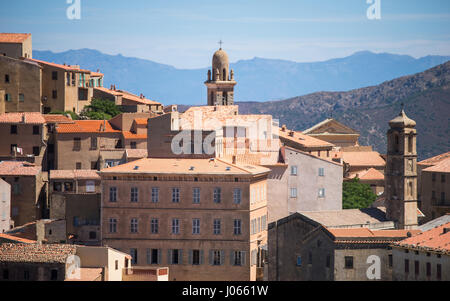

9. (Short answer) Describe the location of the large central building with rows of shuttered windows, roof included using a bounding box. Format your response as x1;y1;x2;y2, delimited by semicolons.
99;158;269;281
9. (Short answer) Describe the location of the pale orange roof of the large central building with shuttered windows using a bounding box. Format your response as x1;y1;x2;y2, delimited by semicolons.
100;158;270;175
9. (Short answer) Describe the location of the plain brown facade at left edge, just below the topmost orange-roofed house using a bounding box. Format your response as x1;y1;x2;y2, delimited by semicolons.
0;55;42;112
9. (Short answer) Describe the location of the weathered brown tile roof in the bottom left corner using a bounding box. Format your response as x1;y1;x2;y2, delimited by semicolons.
0;244;76;263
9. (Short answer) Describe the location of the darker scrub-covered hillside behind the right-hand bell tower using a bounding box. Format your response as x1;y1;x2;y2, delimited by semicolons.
238;61;450;159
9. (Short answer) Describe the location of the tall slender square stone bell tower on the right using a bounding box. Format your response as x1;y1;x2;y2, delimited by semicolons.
385;109;418;229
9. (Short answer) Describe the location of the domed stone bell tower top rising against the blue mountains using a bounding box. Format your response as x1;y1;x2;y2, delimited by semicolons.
205;48;236;106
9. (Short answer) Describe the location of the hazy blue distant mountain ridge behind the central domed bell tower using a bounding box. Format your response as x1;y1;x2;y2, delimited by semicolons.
33;49;450;105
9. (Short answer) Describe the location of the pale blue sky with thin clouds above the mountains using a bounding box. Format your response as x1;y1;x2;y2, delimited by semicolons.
0;0;450;69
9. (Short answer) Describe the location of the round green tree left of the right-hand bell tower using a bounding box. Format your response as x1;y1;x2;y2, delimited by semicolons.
342;178;377;209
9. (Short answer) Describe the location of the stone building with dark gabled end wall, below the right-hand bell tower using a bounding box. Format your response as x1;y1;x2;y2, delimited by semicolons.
268;212;420;281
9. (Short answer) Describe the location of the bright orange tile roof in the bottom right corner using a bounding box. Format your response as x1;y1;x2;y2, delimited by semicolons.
396;223;450;253
